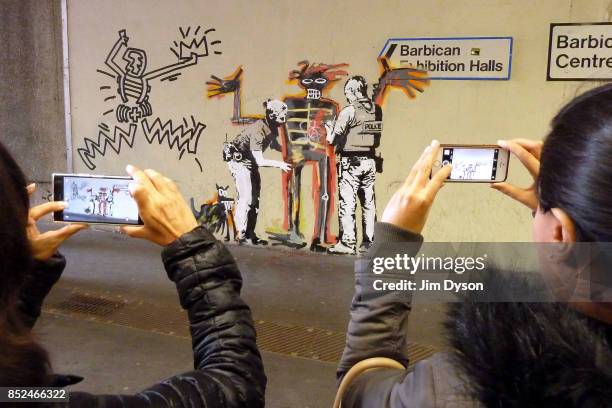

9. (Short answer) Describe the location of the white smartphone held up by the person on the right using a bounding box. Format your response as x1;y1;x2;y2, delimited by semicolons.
431;144;510;183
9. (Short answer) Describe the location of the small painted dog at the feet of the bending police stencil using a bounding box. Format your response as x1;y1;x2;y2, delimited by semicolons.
190;184;238;241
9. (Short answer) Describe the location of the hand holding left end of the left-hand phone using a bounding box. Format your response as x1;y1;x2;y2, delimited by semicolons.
26;183;88;261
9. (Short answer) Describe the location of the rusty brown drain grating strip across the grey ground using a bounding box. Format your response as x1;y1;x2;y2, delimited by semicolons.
45;288;437;366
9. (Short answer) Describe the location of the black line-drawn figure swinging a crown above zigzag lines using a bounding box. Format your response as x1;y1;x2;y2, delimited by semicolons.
77;26;222;171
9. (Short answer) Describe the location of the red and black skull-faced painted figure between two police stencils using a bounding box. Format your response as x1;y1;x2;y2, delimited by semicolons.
207;61;348;251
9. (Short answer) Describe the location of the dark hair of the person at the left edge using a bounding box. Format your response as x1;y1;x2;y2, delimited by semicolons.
0;143;50;387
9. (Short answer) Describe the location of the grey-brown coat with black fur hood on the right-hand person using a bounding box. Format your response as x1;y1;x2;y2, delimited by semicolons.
337;223;612;408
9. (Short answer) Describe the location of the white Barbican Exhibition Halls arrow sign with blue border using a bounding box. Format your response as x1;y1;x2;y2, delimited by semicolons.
379;37;512;80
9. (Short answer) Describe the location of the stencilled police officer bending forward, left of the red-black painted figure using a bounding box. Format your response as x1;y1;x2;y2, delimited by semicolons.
223;100;291;245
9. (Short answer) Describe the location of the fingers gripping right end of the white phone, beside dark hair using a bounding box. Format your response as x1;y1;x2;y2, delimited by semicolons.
491;139;542;211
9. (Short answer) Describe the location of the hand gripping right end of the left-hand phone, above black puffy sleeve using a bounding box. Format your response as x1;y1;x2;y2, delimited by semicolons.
121;166;198;245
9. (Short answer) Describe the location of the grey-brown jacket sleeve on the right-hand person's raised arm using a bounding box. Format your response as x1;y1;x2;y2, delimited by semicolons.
336;223;423;407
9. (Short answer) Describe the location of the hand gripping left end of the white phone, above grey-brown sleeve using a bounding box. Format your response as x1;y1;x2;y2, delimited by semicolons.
381;140;451;234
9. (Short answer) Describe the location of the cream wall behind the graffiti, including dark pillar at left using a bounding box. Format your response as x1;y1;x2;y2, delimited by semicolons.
0;0;611;241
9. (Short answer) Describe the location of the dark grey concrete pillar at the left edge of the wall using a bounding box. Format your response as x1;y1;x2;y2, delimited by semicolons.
0;0;66;181
